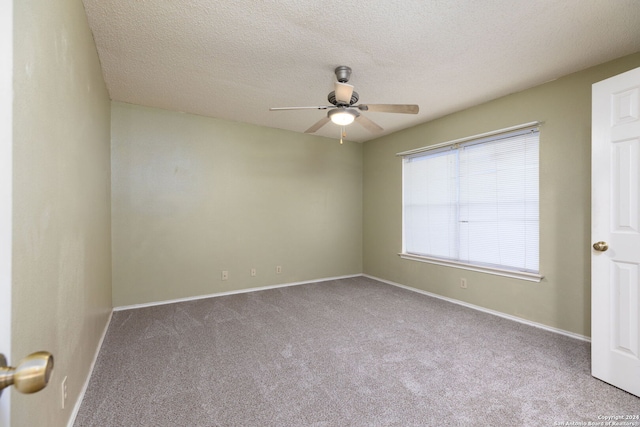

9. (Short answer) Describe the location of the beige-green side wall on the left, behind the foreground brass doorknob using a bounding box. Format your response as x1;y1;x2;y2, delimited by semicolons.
10;0;111;426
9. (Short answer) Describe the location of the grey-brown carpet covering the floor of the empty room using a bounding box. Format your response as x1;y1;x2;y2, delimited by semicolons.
75;277;640;427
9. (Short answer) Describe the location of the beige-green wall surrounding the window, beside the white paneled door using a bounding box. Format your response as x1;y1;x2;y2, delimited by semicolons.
363;54;640;336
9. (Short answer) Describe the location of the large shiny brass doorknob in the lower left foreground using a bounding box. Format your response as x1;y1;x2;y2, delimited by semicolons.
0;351;53;394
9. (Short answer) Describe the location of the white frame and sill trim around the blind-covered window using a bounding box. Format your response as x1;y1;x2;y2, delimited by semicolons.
396;122;544;282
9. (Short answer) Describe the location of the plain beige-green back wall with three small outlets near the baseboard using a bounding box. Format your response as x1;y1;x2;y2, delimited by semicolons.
112;102;362;307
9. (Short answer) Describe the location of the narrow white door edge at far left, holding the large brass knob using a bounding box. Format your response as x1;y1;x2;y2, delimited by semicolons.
0;0;13;427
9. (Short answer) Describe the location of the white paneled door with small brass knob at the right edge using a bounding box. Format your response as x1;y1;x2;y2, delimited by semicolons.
591;68;640;396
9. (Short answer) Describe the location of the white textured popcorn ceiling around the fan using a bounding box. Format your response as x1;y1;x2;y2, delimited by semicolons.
83;0;640;141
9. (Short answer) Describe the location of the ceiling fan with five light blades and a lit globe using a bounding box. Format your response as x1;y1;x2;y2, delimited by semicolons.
269;65;419;143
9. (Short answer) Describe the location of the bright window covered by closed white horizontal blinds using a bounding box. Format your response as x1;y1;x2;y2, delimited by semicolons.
400;126;541;281
